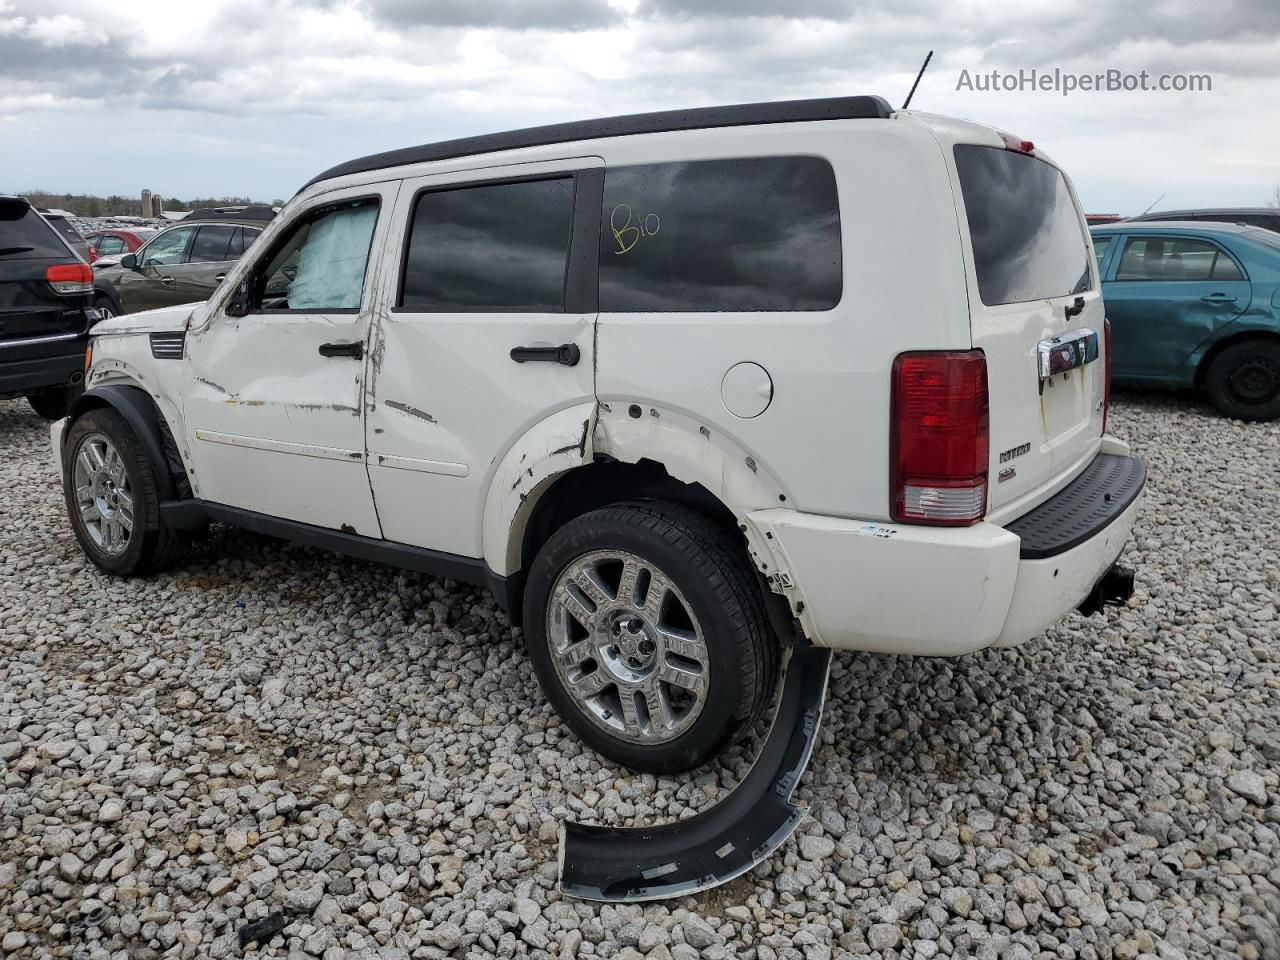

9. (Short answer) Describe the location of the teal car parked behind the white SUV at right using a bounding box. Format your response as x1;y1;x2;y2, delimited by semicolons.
1091;221;1280;420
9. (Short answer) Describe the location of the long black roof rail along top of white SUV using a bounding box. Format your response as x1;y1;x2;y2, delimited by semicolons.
300;96;893;192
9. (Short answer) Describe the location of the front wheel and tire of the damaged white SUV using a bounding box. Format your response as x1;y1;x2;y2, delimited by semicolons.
63;408;182;576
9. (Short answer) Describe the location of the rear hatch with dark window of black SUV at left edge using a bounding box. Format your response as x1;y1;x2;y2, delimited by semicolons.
0;197;92;345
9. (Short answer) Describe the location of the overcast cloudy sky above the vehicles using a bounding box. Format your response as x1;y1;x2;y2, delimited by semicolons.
0;0;1280;212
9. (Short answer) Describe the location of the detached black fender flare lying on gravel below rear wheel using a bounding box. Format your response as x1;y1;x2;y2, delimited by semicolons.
559;643;831;902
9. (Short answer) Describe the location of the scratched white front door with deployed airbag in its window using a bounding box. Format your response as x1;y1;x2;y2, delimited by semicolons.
174;184;396;536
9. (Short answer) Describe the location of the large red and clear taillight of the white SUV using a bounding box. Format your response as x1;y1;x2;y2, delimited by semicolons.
890;349;991;526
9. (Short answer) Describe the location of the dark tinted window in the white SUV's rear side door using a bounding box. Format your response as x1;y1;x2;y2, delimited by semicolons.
399;177;573;312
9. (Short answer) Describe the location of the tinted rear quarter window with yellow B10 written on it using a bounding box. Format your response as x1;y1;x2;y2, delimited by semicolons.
600;156;842;312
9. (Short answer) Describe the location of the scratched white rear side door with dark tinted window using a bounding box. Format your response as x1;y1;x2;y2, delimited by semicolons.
365;157;603;557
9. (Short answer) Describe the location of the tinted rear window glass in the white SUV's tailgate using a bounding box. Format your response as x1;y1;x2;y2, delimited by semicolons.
955;143;1091;306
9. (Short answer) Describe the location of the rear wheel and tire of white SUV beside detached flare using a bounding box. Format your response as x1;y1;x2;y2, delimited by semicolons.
524;502;778;773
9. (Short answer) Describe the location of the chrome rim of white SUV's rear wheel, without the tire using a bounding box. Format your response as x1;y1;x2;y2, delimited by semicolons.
547;550;710;744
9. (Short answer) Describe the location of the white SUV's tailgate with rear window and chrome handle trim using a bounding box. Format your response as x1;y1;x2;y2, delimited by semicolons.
943;131;1106;521
